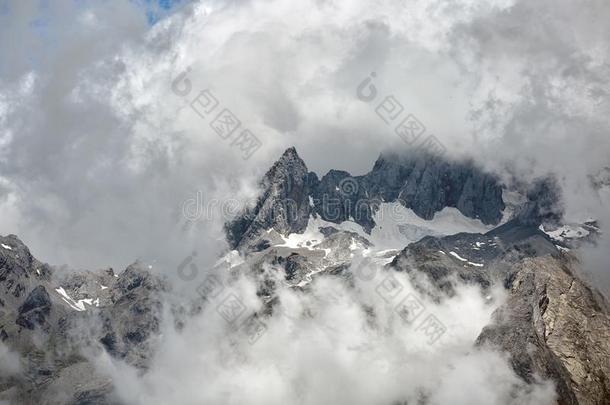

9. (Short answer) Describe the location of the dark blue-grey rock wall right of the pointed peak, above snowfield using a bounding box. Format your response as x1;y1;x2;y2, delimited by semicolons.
313;151;504;234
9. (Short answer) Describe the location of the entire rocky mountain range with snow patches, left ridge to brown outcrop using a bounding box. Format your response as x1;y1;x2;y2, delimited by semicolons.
0;148;610;405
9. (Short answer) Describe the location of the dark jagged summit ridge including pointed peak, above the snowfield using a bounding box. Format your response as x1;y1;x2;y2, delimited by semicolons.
226;148;505;250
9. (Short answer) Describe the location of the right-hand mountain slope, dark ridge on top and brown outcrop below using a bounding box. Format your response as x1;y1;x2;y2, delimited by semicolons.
390;226;610;405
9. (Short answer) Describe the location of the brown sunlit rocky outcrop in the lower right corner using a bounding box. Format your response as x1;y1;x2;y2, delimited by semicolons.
477;256;610;405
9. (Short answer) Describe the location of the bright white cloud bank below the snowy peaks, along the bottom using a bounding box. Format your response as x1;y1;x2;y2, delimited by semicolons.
91;270;554;405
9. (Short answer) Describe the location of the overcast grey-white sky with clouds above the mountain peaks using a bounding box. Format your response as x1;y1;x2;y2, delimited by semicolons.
0;0;610;274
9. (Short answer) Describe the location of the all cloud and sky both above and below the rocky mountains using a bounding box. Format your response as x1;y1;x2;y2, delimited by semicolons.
0;0;610;405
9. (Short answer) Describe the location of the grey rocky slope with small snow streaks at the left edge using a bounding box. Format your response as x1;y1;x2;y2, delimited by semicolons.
0;235;166;405
